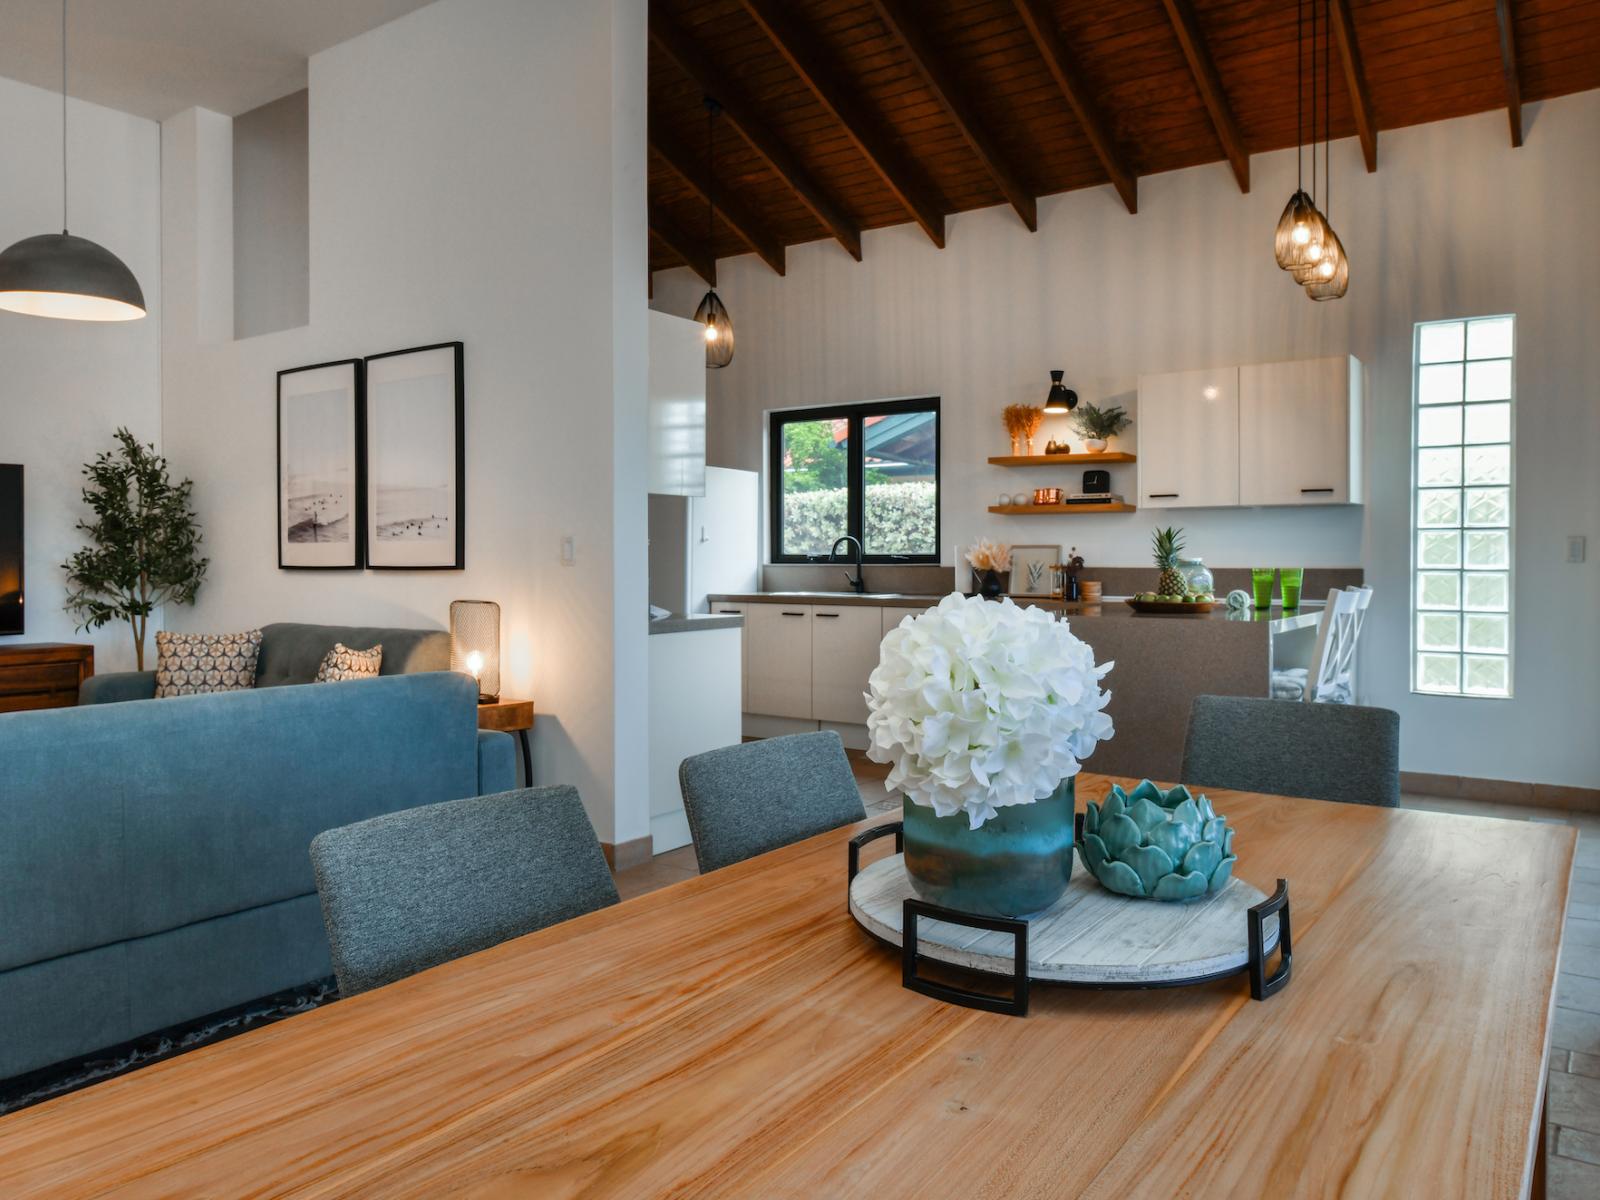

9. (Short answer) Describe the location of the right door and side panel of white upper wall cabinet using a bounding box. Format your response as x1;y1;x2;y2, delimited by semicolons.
1238;355;1362;504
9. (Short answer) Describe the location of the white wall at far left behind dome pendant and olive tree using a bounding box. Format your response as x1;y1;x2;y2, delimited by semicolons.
0;78;162;670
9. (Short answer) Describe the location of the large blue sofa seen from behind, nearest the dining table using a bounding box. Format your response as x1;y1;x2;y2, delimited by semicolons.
0;672;515;1078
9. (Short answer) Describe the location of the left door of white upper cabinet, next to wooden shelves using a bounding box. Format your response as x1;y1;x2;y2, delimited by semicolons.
1134;366;1238;509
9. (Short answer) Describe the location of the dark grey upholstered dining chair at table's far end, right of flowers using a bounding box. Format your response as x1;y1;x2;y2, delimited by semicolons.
1182;696;1400;808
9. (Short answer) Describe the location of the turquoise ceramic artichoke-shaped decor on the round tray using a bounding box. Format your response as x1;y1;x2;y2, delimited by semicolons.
1083;779;1237;901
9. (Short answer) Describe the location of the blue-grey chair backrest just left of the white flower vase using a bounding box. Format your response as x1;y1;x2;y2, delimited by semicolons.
678;730;867;872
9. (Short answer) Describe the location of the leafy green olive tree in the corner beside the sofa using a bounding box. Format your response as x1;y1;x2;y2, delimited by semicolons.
62;429;211;670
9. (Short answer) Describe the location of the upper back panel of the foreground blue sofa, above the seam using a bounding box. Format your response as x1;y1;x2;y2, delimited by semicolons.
0;672;478;970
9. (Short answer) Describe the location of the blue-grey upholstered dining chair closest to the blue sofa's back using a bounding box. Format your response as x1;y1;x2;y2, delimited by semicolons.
310;787;618;995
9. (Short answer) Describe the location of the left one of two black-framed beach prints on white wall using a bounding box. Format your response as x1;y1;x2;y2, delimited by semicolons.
278;358;366;571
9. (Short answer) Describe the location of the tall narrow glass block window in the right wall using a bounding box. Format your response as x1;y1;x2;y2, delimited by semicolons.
1411;317;1515;698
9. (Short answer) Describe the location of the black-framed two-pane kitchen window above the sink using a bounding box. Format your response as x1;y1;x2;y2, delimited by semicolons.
768;397;939;563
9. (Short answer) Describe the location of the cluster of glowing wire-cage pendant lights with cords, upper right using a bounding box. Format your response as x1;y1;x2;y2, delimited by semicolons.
1272;0;1350;301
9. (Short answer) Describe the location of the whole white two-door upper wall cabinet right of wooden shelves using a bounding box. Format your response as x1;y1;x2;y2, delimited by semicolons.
1138;355;1362;509
